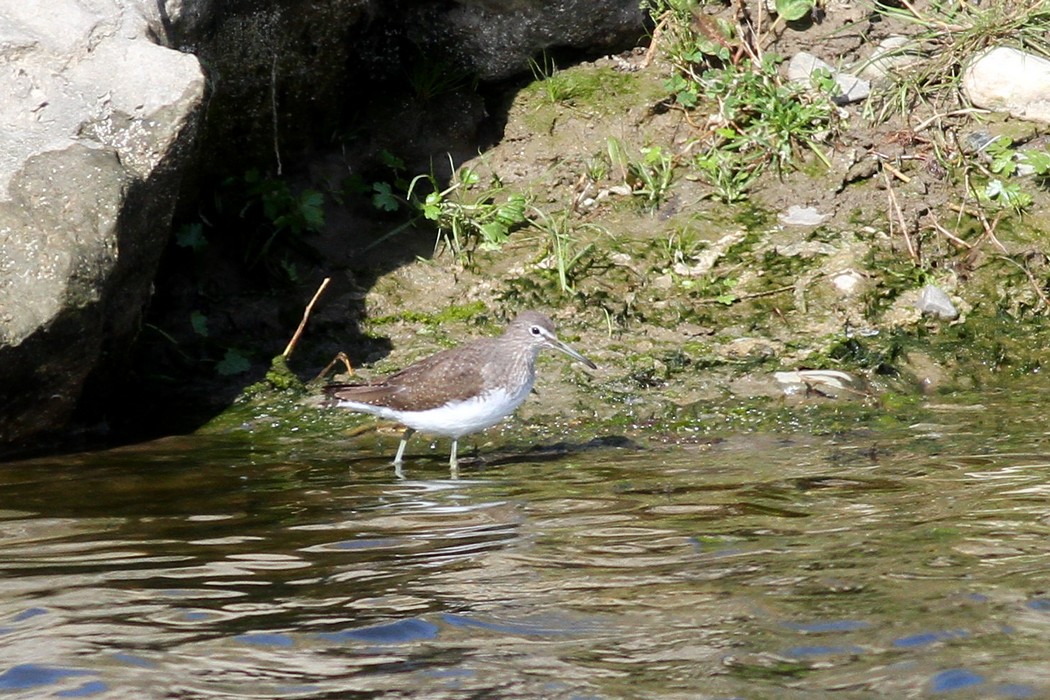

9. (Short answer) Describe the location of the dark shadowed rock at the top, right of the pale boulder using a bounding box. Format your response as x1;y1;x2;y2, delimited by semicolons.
163;0;646;170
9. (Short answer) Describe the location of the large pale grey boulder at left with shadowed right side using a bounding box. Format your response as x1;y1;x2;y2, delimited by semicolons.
0;0;205;445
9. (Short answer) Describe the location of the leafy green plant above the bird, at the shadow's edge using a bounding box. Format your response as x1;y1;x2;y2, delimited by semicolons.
405;160;529;257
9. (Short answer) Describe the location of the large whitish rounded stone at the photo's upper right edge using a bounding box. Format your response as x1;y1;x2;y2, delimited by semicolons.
963;46;1050;124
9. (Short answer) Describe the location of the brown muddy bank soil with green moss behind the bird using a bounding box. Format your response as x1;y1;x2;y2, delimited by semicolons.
124;2;1050;442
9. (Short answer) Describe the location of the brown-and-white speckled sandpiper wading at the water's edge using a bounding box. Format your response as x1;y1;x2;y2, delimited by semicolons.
323;311;597;478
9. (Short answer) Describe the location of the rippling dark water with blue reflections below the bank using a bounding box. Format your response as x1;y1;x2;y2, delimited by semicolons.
0;394;1050;698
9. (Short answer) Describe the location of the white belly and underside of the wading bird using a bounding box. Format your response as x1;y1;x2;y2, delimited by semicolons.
336;378;532;438
